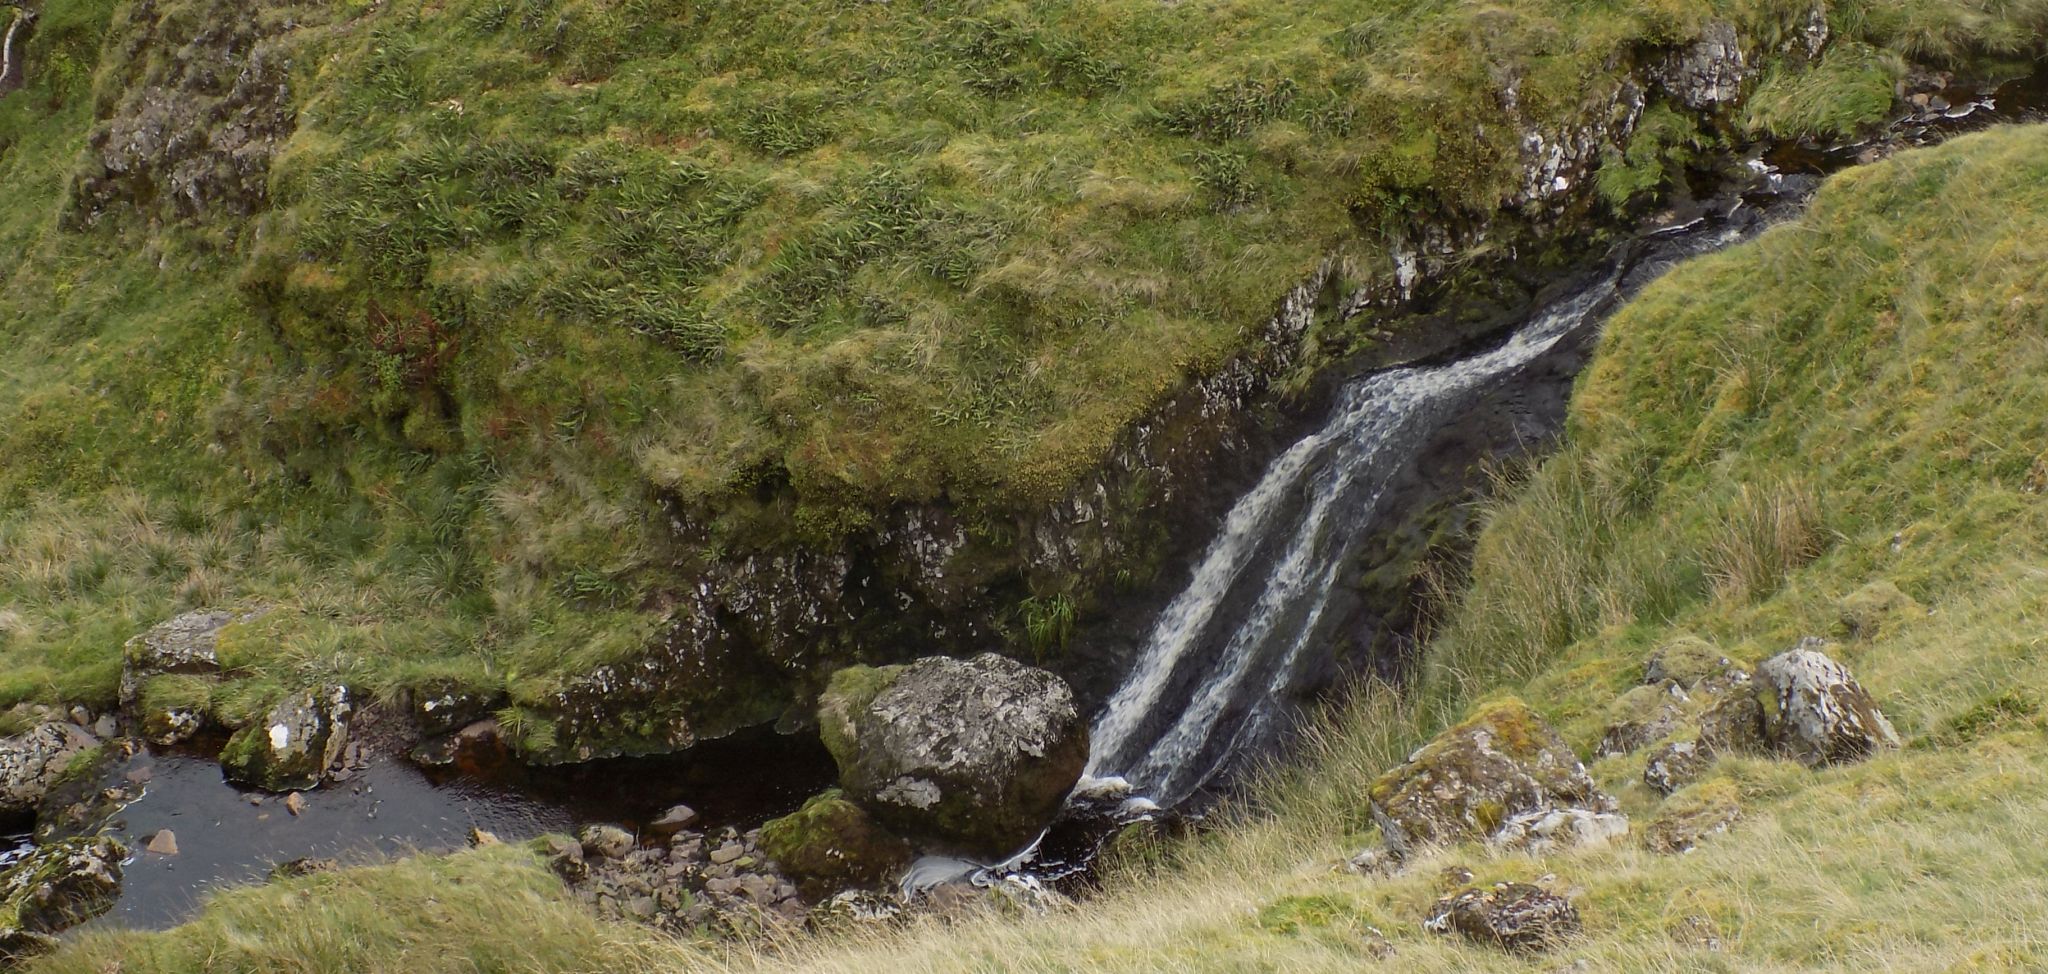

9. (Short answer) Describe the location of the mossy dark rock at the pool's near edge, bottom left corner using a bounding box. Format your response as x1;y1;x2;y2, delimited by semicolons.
0;835;127;951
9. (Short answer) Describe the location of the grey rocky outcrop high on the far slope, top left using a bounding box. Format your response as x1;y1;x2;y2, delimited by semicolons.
68;0;297;225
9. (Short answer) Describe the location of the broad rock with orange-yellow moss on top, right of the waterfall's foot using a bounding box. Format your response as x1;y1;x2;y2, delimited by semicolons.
1370;700;1614;855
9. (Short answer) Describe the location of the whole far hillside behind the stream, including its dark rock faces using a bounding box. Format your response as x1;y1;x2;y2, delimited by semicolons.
0;0;2048;759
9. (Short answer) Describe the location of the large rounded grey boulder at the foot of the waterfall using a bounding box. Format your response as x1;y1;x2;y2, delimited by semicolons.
817;653;1087;857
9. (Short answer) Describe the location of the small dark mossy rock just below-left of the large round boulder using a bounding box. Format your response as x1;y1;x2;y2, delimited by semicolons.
762;790;911;894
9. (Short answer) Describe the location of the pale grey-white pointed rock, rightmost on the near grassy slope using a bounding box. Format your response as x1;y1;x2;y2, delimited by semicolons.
1757;640;1898;767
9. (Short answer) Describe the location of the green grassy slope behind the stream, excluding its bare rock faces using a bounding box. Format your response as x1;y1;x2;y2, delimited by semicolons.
12;0;2048;716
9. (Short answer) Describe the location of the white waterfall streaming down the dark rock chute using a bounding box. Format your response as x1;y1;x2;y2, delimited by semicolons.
1087;221;1747;804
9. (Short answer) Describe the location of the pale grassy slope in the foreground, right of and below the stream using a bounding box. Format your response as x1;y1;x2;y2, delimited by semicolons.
39;116;2048;972
